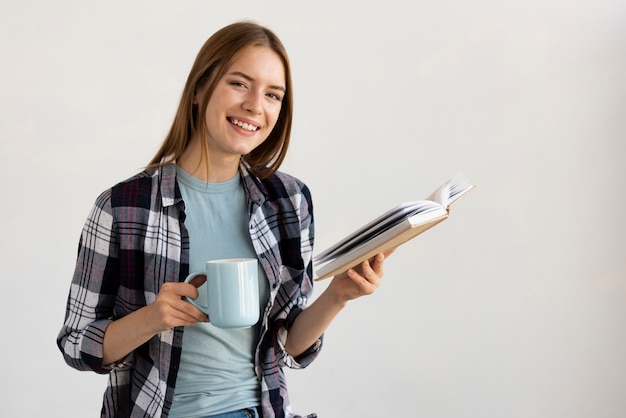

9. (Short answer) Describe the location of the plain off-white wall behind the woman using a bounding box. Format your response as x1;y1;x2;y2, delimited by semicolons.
0;0;626;418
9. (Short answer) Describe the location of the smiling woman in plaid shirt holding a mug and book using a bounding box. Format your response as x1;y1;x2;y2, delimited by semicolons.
58;22;384;417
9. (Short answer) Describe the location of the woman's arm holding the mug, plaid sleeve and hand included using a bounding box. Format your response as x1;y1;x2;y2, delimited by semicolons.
57;190;206;373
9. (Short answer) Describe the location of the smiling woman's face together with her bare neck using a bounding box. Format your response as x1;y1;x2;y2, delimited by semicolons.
178;46;285;182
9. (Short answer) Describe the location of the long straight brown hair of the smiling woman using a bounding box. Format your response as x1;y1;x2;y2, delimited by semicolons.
149;22;293;178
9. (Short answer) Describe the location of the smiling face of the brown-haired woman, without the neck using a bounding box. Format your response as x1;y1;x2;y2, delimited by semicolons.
196;47;286;161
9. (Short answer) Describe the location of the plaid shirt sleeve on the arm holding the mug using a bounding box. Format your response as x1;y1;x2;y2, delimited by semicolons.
57;190;129;373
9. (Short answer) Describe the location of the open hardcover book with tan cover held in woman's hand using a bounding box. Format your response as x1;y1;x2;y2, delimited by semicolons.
313;175;474;280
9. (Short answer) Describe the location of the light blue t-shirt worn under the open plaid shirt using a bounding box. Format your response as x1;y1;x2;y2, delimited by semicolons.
170;167;269;418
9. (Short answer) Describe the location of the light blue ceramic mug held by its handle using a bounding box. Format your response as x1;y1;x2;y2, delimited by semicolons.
185;258;259;328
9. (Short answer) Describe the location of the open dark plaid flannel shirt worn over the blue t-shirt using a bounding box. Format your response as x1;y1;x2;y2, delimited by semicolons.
57;164;322;417
